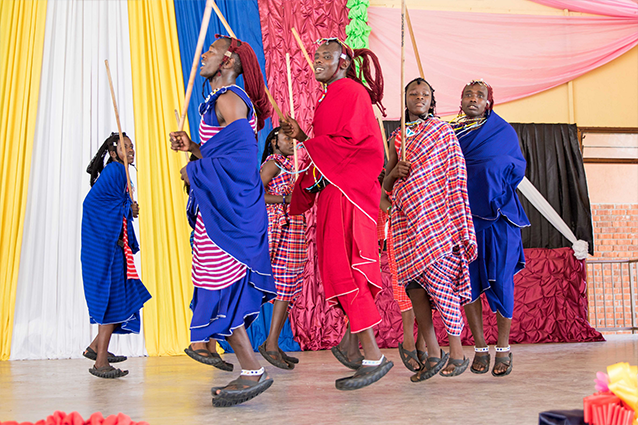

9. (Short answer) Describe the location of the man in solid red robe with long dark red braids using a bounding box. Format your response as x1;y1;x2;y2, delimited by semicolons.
281;38;393;390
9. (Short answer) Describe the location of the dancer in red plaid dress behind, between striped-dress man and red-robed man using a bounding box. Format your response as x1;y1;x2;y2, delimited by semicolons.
259;127;308;369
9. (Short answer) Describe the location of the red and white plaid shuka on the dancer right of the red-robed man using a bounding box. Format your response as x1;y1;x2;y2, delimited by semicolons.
391;118;477;335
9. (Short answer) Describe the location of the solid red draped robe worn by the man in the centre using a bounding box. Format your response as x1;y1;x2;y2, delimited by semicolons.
290;78;383;333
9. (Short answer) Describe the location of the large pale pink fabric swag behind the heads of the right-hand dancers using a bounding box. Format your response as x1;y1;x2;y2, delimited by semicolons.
368;6;638;119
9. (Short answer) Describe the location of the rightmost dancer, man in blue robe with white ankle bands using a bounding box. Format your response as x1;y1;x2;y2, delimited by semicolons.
450;80;530;376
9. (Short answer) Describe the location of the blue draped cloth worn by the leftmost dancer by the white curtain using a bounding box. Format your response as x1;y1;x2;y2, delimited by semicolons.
80;162;151;333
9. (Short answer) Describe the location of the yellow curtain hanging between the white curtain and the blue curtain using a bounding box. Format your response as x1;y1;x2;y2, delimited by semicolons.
128;0;193;356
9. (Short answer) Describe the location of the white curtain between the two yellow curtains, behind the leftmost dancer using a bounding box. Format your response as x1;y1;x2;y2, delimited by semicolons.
11;0;145;359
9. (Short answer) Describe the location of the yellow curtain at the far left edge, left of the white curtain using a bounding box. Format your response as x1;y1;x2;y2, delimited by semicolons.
0;0;47;360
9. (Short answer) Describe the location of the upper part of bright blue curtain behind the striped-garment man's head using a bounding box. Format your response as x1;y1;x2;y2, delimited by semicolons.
174;0;272;159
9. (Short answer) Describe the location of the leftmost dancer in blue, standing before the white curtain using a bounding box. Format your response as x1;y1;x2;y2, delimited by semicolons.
81;133;151;378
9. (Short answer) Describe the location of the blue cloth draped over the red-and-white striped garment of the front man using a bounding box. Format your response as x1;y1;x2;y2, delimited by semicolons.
186;103;277;342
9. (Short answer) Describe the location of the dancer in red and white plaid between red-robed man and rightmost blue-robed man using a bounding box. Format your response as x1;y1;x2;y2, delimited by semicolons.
384;78;476;382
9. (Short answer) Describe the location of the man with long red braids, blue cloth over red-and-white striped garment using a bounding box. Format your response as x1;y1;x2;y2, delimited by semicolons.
170;35;277;407
